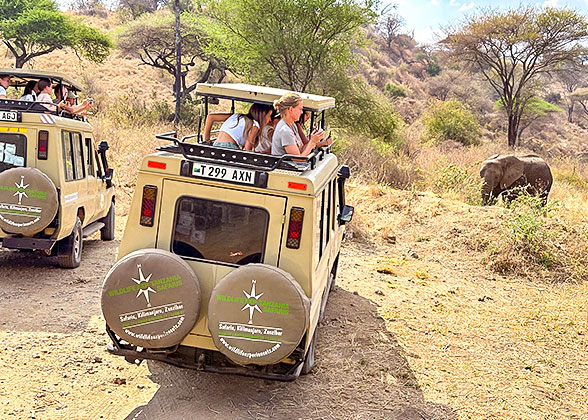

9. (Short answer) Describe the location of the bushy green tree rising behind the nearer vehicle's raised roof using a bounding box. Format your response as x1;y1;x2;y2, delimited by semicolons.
207;0;376;91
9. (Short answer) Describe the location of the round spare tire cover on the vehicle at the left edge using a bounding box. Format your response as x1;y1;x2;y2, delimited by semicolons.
0;168;59;235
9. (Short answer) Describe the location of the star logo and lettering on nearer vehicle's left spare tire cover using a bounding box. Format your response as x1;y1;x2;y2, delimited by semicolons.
106;264;185;340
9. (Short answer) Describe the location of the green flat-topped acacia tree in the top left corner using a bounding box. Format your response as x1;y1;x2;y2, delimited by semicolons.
0;0;112;68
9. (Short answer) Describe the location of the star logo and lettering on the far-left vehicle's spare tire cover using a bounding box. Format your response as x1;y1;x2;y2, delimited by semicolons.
0;175;47;227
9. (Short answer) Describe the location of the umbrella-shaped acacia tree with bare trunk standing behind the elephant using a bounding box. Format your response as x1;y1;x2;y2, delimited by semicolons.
442;6;588;147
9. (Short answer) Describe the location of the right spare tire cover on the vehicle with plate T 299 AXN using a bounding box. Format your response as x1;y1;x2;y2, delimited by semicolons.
208;264;310;365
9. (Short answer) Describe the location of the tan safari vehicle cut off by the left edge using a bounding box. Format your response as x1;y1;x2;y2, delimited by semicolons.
0;69;114;268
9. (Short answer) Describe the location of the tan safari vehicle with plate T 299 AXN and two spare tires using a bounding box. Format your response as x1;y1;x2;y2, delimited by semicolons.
102;84;353;380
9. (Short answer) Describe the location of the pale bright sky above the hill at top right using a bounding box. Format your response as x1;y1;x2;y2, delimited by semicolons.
390;0;588;44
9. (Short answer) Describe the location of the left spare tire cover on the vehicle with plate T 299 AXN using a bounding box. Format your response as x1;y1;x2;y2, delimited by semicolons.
102;249;201;349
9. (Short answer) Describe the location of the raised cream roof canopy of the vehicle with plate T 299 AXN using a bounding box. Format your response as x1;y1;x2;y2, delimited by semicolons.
196;83;335;112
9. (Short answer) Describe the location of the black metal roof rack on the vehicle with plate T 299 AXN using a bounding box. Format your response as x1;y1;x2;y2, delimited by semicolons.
155;131;324;172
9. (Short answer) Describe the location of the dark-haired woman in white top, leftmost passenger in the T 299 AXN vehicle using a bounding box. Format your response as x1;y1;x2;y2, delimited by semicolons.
204;104;272;150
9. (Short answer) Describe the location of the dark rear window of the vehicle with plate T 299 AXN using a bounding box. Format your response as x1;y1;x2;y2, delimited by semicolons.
172;197;269;265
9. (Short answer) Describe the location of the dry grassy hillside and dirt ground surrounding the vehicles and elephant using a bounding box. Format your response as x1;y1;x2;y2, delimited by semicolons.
0;7;588;420
